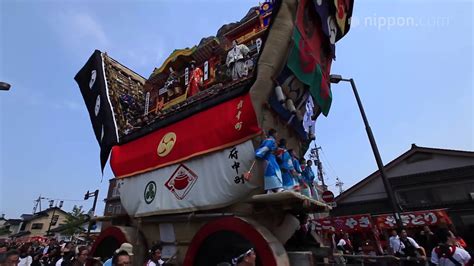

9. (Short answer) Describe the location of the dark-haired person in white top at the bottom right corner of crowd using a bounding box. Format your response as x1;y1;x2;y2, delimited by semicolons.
431;228;471;266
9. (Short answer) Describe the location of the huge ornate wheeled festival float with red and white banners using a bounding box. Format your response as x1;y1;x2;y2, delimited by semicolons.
75;0;353;265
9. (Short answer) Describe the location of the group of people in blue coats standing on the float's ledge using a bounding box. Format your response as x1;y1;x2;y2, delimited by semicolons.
255;129;318;199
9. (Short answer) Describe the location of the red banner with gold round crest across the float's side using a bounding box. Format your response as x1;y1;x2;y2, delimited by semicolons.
110;94;261;178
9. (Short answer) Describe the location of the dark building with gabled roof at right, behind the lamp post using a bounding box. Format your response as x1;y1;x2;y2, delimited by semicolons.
331;144;474;245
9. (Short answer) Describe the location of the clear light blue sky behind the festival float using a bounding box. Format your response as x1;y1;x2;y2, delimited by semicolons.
0;0;474;218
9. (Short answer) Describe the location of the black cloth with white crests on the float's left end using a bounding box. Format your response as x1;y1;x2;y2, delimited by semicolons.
74;50;119;173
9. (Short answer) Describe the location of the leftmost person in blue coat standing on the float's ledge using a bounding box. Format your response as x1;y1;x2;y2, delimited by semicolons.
255;129;283;193
